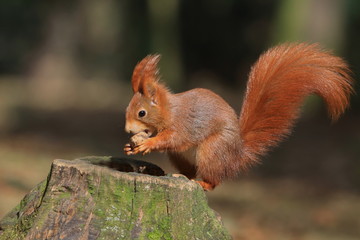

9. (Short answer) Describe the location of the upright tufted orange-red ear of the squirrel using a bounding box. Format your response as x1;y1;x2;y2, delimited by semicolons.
131;54;160;95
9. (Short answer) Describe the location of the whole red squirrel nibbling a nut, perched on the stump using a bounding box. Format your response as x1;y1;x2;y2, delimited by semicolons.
124;43;353;190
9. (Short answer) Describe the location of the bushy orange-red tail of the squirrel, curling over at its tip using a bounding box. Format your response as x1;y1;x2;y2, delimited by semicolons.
239;44;353;167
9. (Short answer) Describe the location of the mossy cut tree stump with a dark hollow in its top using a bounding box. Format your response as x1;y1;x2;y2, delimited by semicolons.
0;157;231;240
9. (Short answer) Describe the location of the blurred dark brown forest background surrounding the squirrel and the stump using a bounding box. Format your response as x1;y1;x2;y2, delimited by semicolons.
0;0;360;240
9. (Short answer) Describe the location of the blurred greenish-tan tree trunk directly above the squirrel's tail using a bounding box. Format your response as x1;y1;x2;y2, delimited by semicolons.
274;0;347;51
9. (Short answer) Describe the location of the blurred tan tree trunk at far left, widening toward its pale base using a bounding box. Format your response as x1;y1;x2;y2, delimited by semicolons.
29;3;81;109
